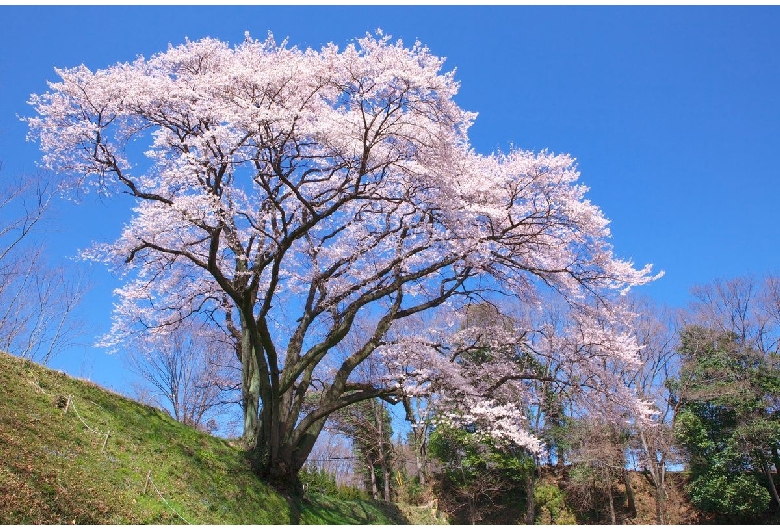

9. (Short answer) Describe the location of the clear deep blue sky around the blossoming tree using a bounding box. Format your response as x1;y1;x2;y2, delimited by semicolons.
0;6;780;389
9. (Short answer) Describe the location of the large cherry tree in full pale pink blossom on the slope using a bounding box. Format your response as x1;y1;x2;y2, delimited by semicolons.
27;32;653;484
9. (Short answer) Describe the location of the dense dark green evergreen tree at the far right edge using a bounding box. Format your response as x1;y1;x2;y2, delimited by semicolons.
672;326;780;518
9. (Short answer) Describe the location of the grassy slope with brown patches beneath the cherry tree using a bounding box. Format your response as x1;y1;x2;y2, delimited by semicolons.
0;353;407;524
